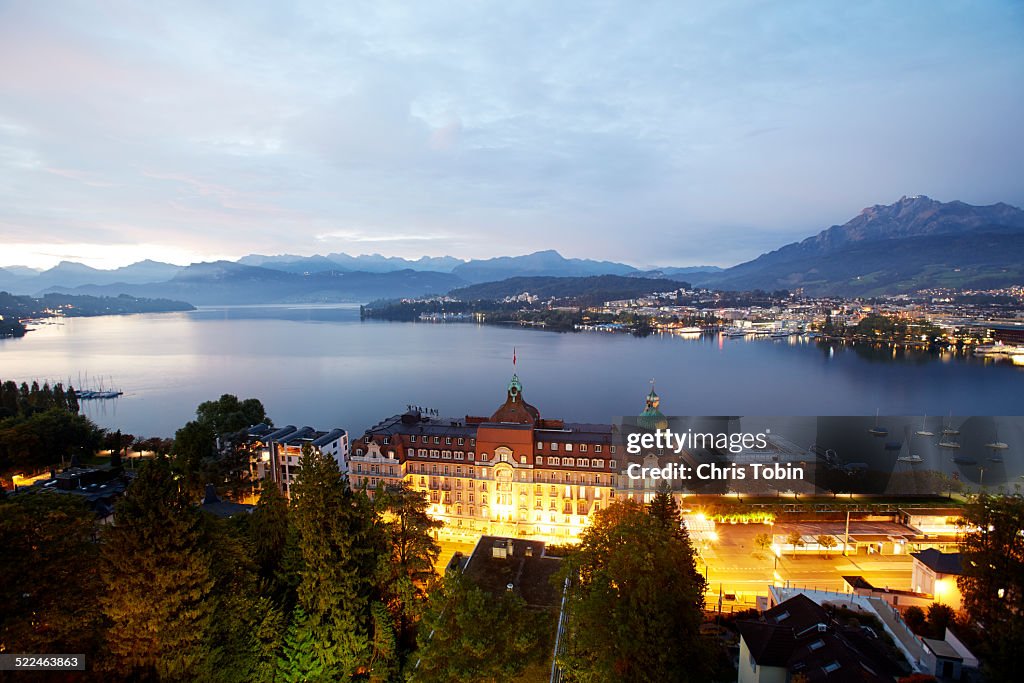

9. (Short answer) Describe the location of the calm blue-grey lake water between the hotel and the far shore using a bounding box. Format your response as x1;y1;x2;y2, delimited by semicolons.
0;305;1024;436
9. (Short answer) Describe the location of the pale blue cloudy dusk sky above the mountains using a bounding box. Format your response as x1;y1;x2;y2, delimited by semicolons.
0;0;1024;267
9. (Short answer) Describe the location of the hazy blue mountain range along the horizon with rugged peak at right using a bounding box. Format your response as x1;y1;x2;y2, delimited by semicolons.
0;196;1024;305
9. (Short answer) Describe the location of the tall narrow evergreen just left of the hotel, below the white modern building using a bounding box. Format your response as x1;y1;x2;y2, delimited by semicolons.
291;446;373;681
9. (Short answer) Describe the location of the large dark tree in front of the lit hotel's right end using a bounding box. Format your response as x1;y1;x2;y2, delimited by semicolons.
559;501;715;682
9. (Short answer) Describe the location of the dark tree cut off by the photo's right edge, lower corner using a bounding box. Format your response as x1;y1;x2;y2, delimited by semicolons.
956;496;1024;681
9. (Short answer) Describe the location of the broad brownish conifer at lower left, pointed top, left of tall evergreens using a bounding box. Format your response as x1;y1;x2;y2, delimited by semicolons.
102;458;216;680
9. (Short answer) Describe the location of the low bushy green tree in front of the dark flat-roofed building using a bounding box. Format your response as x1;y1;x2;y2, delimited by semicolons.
411;571;546;683
